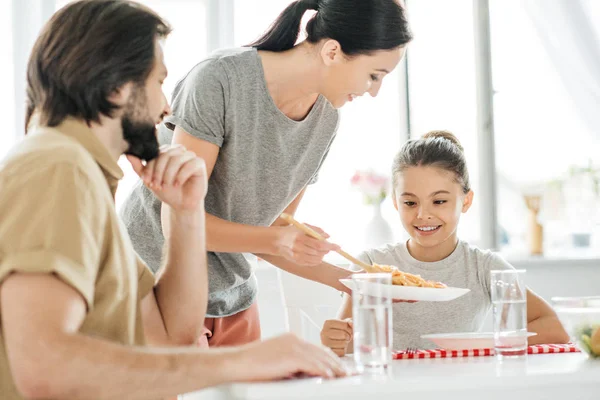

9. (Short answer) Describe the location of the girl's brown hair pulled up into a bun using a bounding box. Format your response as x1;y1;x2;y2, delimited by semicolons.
392;131;471;194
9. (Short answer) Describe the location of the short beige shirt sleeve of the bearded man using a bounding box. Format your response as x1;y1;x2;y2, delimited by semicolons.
0;163;106;309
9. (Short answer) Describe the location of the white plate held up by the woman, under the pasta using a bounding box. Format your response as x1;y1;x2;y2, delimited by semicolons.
340;279;469;301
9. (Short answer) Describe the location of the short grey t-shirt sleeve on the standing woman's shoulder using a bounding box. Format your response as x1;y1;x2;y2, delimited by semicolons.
165;59;229;147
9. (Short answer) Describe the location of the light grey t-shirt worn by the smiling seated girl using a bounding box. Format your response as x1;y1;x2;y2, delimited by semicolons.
352;241;513;350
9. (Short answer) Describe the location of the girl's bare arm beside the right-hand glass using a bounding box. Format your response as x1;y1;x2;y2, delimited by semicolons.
527;289;569;345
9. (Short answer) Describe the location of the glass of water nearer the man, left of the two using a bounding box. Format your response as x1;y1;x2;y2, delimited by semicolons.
352;273;392;373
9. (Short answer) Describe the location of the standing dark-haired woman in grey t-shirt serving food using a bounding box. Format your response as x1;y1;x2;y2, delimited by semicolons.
122;0;411;346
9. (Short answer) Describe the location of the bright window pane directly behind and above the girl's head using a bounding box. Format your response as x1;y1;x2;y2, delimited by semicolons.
407;0;480;244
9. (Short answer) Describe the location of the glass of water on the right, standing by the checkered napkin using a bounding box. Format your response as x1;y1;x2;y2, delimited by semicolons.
491;269;527;360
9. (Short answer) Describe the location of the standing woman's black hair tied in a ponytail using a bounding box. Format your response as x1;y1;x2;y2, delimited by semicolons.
249;0;412;56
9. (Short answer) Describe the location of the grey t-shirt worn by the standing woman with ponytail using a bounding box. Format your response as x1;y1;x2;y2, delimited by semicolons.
121;48;339;317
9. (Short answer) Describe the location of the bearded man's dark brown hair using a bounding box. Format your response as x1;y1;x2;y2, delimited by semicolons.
25;0;171;130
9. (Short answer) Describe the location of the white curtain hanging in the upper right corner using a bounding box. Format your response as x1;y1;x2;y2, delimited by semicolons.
523;0;600;138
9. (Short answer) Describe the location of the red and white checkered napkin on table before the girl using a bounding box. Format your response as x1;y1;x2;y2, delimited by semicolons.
392;343;580;360
